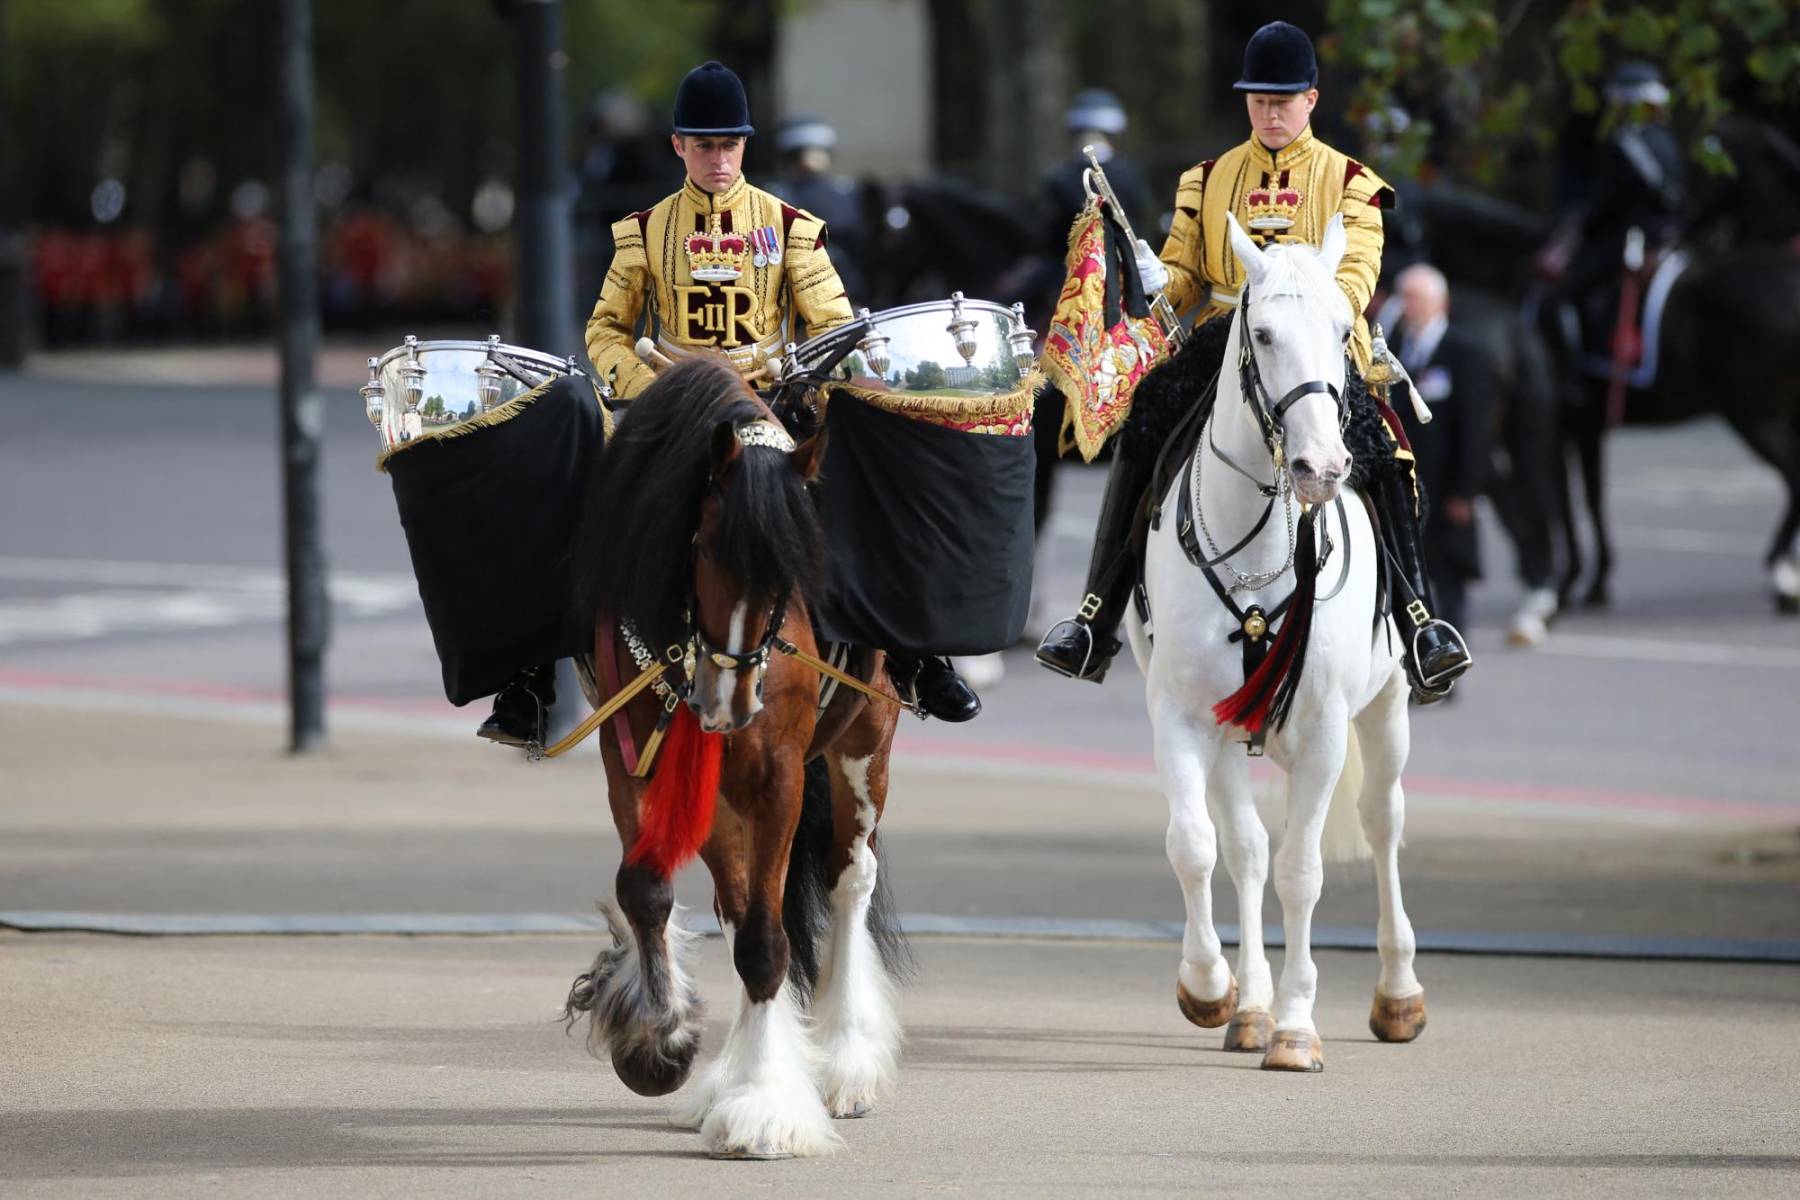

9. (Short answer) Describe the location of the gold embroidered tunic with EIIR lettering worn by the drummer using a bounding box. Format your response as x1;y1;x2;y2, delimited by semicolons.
587;175;853;396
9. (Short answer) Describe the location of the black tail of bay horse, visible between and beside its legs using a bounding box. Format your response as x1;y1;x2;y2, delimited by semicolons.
781;757;913;995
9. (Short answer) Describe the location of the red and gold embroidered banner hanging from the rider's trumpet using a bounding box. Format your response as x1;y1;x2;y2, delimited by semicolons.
1044;200;1168;462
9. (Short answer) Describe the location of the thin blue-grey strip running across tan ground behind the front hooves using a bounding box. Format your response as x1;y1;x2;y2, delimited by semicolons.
0;910;1800;963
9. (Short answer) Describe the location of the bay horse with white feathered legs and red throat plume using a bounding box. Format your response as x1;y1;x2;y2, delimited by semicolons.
565;358;904;1159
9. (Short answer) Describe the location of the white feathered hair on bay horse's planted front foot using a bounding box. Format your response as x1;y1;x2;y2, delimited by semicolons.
686;984;842;1157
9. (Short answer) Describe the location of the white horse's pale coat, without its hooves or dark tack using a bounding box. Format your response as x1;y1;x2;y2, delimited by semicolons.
1127;228;1420;1057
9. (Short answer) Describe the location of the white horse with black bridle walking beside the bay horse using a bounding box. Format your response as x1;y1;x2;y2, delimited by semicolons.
1129;218;1426;1070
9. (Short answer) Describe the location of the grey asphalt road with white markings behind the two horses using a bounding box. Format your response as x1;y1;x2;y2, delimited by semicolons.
0;347;1800;820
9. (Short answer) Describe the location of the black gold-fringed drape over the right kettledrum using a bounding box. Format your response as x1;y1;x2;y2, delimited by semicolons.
814;381;1037;655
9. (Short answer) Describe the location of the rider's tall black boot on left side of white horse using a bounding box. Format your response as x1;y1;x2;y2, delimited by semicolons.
1037;437;1156;684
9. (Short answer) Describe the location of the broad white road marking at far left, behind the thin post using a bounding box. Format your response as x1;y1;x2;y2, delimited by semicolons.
0;558;419;646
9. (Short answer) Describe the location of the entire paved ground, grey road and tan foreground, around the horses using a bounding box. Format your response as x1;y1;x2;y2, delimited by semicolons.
0;347;1800;1196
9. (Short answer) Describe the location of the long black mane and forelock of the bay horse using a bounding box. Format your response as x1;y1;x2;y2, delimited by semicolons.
572;356;821;651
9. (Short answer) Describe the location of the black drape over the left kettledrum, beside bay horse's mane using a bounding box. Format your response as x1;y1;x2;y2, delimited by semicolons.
382;374;608;705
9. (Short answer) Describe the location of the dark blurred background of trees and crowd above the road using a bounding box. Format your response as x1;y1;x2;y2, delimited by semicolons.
0;0;1800;347
